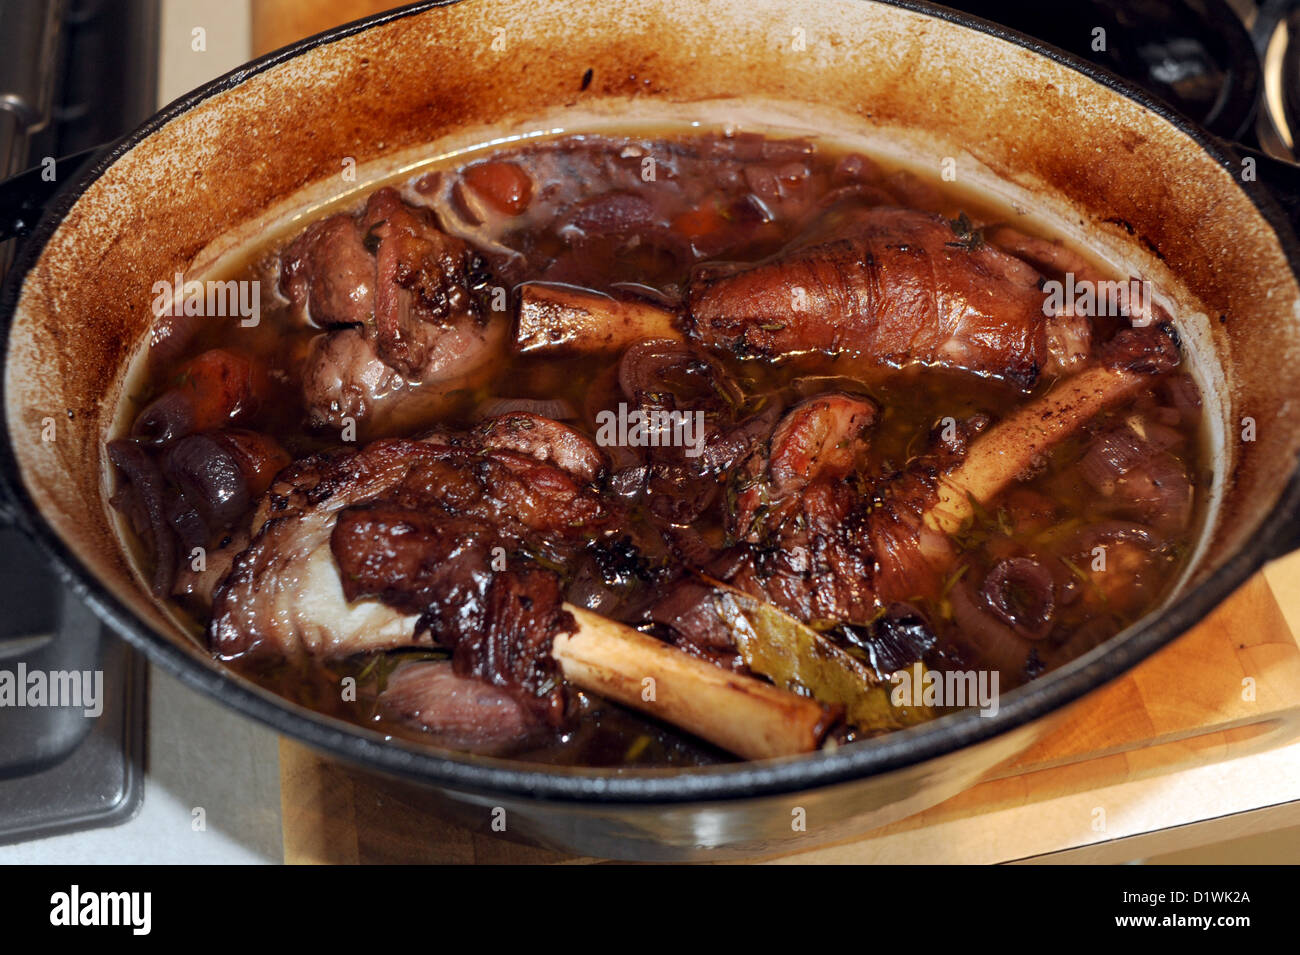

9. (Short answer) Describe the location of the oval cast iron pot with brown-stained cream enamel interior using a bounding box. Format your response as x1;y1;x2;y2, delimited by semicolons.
3;0;1300;859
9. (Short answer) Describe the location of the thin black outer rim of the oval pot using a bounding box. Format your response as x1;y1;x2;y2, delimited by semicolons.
0;0;1300;806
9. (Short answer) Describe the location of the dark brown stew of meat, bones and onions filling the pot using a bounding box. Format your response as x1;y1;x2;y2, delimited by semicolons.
108;130;1208;767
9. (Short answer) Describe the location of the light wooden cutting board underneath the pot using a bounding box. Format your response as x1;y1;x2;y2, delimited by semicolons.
252;0;1300;863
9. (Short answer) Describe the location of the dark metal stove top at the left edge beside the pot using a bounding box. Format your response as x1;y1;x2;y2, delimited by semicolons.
0;0;157;842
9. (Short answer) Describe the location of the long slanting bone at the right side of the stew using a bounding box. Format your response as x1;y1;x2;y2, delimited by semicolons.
924;365;1151;534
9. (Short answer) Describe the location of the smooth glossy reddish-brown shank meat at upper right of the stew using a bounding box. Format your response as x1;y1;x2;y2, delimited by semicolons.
689;208;1048;388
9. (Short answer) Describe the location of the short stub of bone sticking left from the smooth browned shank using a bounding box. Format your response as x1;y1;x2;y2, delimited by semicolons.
515;285;683;355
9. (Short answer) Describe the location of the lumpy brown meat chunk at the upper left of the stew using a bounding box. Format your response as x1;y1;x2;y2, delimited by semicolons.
280;188;507;434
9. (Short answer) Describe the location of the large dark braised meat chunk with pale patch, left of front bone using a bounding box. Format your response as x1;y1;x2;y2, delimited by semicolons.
208;421;608;724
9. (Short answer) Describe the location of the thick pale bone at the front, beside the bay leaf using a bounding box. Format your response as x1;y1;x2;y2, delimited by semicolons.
551;604;829;759
